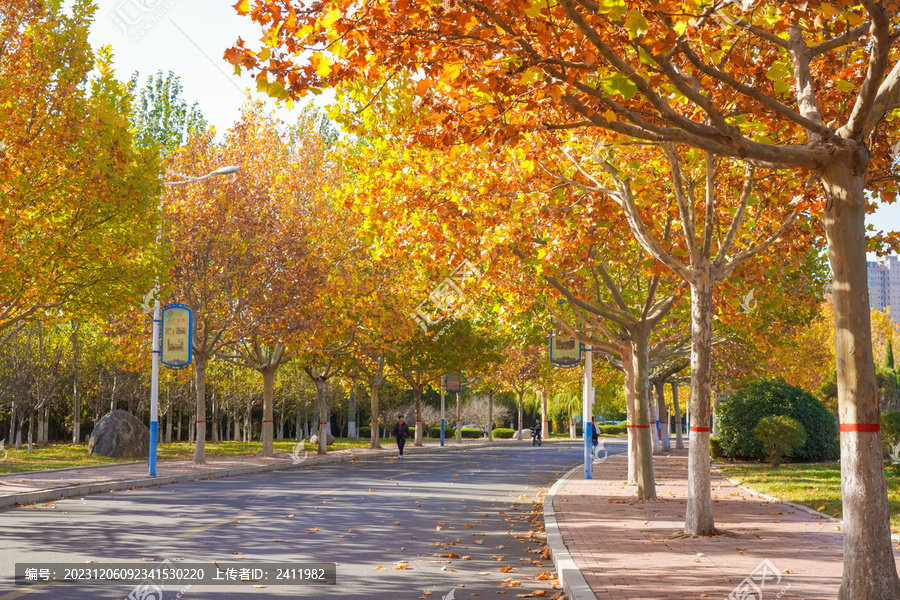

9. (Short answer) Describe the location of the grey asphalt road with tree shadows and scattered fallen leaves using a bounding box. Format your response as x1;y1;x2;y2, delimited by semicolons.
0;442;618;600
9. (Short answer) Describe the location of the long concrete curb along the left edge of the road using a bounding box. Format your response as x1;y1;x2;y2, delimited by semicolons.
0;442;512;508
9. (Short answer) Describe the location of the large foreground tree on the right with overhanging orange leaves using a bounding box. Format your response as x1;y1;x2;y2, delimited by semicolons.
232;0;900;600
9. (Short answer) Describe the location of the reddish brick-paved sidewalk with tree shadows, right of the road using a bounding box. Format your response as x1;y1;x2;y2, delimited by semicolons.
553;450;900;600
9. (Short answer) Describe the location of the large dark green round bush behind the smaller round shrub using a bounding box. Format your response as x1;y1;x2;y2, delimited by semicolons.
716;379;839;462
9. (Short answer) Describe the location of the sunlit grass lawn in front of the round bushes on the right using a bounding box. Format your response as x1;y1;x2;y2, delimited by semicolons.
717;463;900;533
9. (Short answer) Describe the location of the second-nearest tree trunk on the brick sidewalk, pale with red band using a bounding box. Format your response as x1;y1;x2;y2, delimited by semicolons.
684;276;712;535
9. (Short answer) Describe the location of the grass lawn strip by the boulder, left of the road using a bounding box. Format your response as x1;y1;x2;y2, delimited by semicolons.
0;438;384;475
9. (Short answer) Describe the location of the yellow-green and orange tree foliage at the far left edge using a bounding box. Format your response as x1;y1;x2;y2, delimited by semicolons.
0;0;160;332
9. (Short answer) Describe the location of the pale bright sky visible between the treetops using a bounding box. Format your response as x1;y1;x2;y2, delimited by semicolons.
90;0;900;248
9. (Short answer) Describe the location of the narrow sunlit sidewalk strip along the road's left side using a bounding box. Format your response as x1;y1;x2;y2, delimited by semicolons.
0;440;502;508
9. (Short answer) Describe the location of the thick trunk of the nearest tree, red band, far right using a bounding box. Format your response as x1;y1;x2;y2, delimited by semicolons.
824;157;900;600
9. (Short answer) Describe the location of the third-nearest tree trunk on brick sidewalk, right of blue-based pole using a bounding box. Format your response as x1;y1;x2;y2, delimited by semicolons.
631;327;656;500
